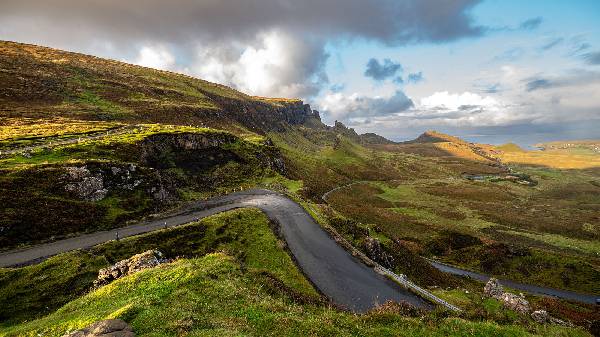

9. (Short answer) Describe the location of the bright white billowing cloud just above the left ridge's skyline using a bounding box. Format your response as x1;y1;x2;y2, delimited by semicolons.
190;31;329;97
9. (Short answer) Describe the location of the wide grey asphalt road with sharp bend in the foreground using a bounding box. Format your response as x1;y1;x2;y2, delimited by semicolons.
0;190;433;312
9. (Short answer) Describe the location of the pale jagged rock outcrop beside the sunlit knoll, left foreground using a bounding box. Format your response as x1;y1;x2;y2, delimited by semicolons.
94;250;169;288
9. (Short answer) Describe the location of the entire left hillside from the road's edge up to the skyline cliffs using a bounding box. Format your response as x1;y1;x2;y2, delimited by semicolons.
0;41;320;250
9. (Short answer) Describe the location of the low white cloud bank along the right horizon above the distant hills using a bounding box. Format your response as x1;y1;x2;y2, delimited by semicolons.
347;65;600;139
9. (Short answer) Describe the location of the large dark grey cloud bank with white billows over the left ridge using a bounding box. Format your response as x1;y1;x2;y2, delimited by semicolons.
0;0;485;97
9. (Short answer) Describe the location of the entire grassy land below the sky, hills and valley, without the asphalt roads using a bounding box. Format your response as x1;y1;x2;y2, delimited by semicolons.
0;42;600;336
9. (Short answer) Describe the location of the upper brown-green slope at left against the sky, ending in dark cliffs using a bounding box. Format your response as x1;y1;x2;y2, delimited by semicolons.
0;41;320;133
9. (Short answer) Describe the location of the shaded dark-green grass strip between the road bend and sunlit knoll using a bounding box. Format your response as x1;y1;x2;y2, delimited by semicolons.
0;209;316;323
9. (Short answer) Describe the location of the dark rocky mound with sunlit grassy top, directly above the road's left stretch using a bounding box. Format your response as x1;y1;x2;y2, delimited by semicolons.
0;124;283;249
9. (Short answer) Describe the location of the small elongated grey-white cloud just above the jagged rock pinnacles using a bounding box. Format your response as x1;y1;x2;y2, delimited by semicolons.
319;90;414;121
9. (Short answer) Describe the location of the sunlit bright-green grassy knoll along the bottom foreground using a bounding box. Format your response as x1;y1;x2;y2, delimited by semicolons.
0;253;586;336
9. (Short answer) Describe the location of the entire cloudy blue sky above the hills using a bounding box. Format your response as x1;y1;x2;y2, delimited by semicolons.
0;0;600;146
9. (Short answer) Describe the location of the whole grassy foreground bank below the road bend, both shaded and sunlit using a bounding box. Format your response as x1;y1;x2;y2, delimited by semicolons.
0;209;587;336
